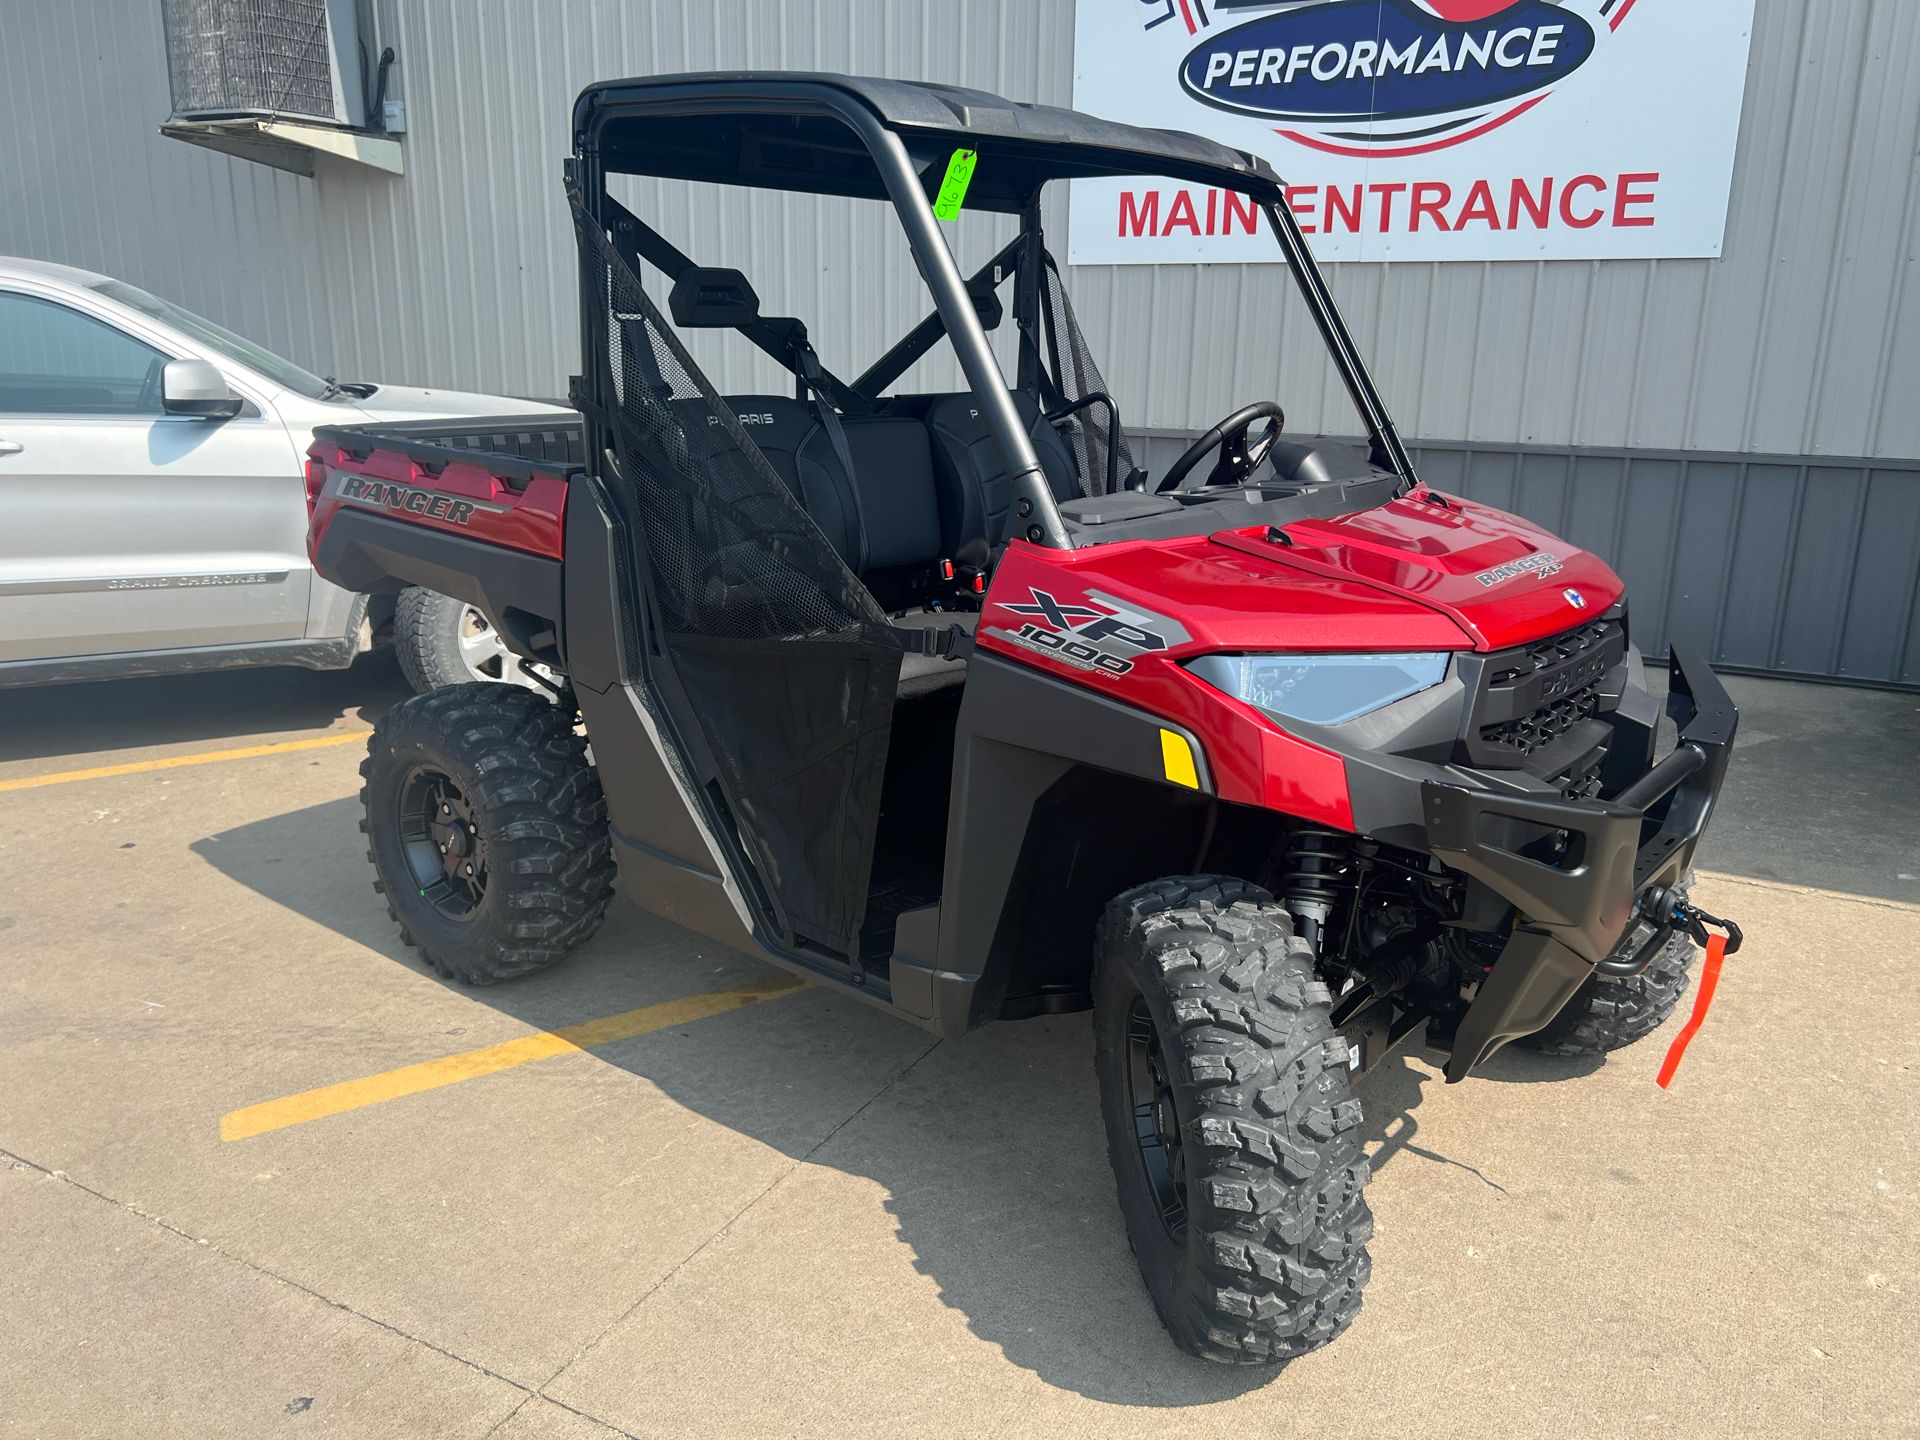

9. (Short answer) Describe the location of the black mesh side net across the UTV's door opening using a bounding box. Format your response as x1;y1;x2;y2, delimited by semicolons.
574;192;906;956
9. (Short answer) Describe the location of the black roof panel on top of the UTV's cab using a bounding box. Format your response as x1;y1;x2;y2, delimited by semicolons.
574;71;1281;211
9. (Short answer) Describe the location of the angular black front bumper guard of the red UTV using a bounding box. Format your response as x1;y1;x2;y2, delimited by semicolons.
1421;645;1740;1081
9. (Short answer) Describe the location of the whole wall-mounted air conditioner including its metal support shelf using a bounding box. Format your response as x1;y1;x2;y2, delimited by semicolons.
159;0;403;175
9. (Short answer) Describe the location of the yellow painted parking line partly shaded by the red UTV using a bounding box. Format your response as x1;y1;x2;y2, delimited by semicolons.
221;975;806;1140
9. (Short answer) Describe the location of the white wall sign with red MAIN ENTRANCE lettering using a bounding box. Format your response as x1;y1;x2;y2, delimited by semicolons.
1068;0;1755;265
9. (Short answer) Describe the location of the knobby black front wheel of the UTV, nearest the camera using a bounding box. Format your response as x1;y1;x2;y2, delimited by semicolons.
1094;876;1373;1363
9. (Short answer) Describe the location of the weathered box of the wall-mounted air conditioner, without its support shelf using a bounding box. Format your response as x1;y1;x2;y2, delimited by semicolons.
161;0;367;127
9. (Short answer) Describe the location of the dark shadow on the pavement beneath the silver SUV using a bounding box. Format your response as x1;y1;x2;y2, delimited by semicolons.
0;649;413;762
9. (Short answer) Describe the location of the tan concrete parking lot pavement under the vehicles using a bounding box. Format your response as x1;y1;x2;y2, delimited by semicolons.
0;662;1920;1440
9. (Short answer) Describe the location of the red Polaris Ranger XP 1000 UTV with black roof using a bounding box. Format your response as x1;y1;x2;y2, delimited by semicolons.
309;73;1734;1361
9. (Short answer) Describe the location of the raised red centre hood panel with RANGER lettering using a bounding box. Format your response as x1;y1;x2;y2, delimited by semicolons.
1213;490;1624;651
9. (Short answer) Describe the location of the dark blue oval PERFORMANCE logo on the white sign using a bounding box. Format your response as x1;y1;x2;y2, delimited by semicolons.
1179;0;1634;154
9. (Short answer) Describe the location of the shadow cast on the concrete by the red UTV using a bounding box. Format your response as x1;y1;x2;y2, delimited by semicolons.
192;799;1582;1405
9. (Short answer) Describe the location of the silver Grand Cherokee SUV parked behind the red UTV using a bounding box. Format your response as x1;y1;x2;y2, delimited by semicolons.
0;257;566;689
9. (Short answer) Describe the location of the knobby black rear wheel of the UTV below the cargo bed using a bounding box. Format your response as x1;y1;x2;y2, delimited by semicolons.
361;684;614;985
